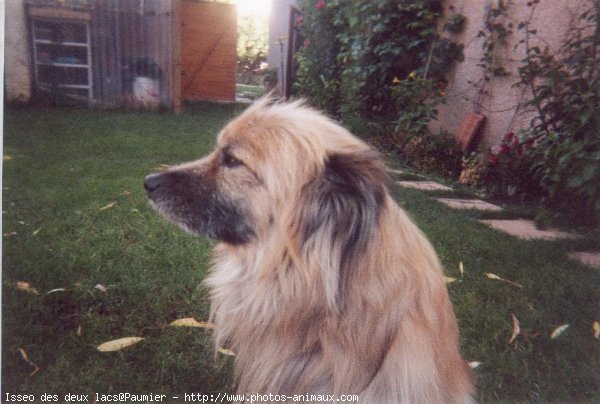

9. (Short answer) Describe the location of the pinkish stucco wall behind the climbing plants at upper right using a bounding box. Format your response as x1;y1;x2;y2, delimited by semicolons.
435;0;589;146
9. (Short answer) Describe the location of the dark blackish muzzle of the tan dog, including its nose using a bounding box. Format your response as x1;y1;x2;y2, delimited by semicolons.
144;171;255;244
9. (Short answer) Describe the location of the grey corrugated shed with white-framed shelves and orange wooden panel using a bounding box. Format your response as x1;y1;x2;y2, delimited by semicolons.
12;0;237;110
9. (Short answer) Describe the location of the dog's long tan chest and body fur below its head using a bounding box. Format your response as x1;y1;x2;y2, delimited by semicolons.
206;195;470;403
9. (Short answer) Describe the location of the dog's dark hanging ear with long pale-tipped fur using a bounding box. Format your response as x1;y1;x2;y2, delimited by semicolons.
293;150;388;308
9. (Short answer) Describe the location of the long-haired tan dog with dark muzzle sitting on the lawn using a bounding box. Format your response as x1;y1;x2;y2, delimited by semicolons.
144;99;473;404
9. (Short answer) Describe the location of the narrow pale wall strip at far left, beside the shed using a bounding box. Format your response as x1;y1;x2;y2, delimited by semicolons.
4;0;31;101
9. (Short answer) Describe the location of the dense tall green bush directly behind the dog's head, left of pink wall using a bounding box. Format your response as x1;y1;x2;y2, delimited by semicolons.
296;0;462;118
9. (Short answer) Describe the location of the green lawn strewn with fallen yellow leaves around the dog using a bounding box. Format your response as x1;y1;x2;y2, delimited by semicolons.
2;104;600;402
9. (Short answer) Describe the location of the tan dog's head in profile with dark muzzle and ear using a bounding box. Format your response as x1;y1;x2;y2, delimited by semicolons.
144;99;387;270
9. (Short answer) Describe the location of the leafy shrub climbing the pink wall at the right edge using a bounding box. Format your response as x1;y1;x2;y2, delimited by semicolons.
519;0;600;221
